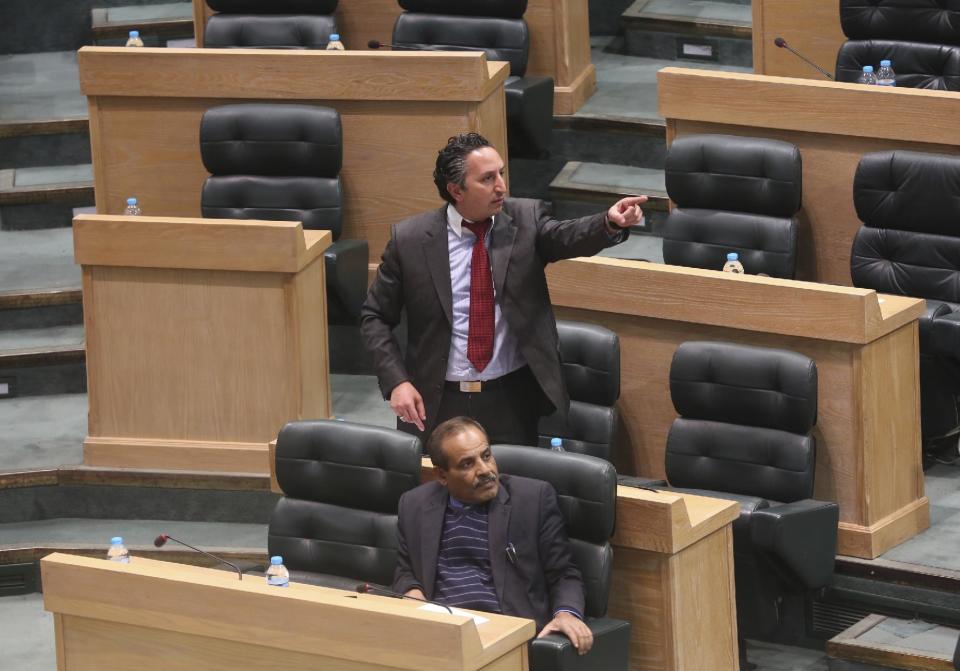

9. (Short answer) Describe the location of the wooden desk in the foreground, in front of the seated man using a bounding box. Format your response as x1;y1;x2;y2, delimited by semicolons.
40;553;535;671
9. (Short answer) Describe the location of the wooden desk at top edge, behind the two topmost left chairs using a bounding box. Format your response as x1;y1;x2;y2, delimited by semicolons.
193;0;597;114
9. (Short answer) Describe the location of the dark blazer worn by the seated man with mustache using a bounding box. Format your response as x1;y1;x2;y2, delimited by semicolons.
393;475;584;631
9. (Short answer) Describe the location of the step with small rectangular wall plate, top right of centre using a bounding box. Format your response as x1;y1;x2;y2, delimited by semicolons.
621;0;753;66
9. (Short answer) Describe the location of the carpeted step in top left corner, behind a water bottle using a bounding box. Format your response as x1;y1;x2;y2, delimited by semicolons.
90;2;193;47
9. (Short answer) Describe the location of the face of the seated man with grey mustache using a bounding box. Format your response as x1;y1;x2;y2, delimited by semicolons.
437;427;500;504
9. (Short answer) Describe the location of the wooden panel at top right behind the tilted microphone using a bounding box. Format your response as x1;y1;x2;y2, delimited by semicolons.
753;0;840;79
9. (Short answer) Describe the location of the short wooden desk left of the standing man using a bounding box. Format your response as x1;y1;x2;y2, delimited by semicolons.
73;215;331;474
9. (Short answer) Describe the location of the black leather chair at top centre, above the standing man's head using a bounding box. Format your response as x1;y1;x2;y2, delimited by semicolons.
393;0;553;156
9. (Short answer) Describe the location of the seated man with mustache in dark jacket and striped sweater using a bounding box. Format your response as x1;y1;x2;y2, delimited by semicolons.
393;417;593;654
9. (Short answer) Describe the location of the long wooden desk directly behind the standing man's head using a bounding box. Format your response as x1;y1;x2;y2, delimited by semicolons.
79;47;509;264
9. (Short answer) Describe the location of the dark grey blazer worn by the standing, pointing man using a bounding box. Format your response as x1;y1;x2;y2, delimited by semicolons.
360;198;627;433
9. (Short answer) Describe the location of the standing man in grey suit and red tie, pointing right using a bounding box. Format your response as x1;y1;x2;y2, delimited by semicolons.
360;133;647;445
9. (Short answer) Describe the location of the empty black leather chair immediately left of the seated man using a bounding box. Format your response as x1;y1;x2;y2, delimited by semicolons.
267;420;421;590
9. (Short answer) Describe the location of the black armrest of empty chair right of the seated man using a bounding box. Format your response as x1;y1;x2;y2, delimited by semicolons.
750;499;840;589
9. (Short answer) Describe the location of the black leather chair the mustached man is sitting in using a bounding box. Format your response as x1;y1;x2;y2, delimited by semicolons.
493;445;630;671
